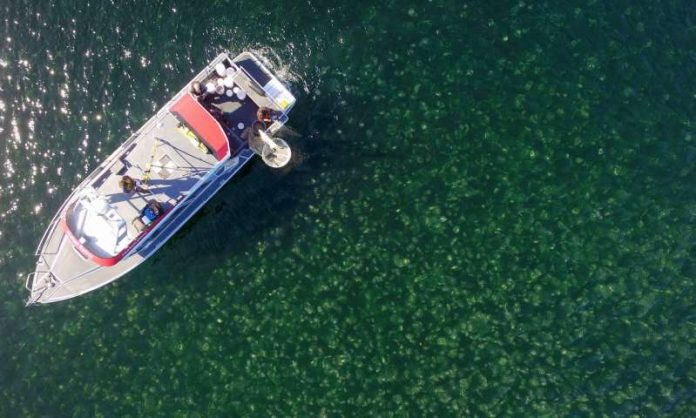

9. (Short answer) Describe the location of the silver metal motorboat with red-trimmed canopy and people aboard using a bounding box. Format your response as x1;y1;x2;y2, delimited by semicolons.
25;52;296;305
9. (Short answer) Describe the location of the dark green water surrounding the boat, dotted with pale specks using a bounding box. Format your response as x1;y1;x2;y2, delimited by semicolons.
0;0;696;417
